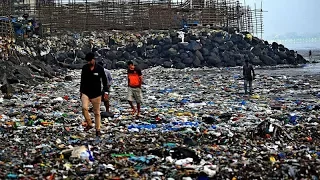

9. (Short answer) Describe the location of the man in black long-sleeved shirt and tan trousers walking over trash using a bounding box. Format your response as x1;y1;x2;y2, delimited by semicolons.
80;52;109;136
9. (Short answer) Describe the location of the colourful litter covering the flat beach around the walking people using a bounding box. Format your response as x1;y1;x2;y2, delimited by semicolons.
0;67;320;180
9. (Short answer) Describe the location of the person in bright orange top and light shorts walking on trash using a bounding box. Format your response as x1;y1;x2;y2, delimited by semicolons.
127;61;142;117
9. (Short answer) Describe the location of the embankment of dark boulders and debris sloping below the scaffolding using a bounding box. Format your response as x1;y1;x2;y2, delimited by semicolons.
0;29;307;93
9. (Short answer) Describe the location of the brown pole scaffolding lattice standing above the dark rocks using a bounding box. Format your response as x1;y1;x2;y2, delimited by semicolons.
0;0;265;35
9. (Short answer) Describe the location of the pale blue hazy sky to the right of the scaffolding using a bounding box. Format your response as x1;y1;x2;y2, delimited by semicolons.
244;0;320;37
